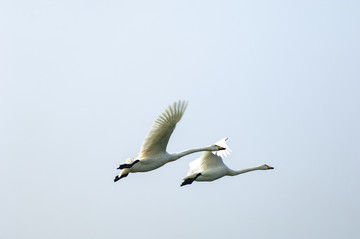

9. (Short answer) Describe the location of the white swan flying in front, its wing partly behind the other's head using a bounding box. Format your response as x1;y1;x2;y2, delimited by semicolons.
180;138;274;186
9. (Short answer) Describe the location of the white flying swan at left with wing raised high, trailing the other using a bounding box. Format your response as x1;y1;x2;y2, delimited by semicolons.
114;101;225;182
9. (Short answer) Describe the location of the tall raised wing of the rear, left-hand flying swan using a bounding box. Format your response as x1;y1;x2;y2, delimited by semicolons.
139;101;187;158
